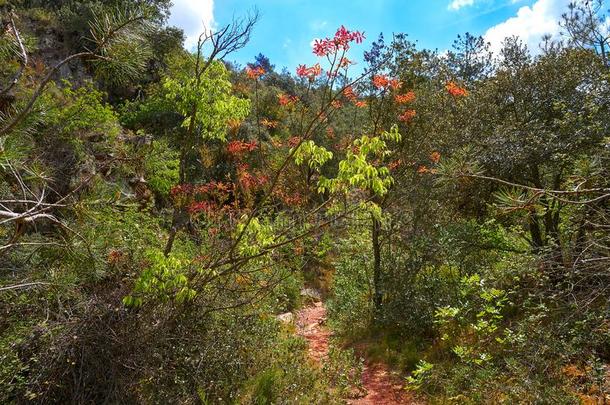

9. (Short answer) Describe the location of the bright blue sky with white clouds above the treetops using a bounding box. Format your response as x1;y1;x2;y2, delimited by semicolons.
169;0;570;70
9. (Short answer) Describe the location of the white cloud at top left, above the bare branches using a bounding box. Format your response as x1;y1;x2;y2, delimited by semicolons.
169;0;214;49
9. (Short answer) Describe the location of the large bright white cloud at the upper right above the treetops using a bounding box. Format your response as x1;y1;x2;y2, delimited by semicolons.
484;0;570;53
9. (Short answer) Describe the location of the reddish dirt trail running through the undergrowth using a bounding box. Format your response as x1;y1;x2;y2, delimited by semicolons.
296;302;418;405
